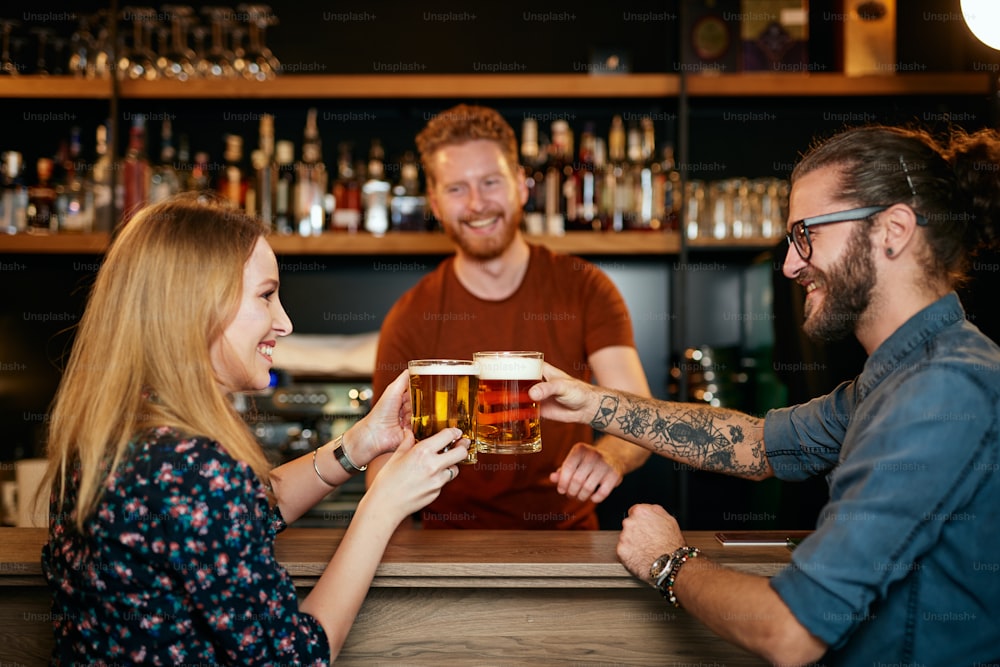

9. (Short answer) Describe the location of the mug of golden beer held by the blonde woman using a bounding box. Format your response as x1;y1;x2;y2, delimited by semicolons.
409;359;478;463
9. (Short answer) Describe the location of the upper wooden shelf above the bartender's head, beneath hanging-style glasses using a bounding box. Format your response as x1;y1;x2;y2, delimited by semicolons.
0;72;993;99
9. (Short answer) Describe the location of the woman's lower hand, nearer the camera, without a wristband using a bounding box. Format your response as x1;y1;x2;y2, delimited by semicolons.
361;428;469;522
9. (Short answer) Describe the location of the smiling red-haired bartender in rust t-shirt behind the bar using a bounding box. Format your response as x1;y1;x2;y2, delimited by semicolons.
367;104;649;530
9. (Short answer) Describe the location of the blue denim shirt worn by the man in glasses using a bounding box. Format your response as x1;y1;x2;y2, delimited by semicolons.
764;293;1000;667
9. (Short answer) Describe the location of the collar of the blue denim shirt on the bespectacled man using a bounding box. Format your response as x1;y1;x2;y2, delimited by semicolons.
857;292;965;400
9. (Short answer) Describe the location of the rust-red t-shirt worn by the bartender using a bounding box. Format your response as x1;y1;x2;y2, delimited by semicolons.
373;246;635;529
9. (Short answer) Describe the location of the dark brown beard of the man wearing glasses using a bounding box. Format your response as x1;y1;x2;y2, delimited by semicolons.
802;225;876;342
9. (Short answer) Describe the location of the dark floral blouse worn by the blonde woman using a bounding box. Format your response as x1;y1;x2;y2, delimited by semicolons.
42;428;330;665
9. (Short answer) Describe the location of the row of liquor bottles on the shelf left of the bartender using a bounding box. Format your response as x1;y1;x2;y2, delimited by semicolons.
0;109;424;236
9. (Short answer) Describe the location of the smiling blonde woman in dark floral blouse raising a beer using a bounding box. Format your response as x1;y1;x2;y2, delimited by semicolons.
35;199;467;665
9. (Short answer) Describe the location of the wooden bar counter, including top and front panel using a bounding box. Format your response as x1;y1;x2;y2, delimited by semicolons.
0;528;791;667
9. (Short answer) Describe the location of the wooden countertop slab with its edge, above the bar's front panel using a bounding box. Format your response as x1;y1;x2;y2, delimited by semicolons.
0;528;791;588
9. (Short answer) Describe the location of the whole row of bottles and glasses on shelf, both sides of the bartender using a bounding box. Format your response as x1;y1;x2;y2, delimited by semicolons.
0;109;787;239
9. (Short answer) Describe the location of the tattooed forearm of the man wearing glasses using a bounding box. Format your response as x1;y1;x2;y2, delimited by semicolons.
591;395;770;477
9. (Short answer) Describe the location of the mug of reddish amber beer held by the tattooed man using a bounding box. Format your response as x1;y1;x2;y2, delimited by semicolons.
473;352;542;454
